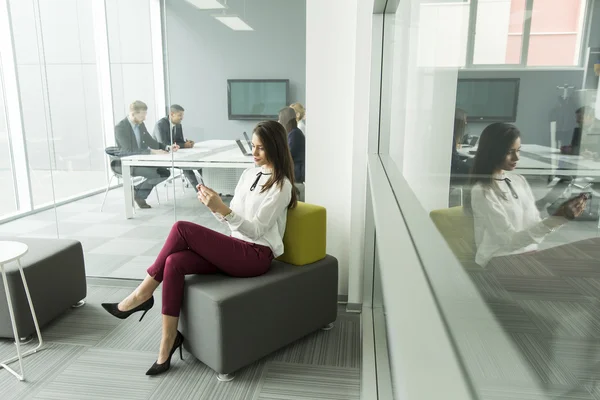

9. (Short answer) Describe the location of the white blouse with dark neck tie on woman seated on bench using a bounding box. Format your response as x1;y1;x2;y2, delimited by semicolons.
214;167;292;257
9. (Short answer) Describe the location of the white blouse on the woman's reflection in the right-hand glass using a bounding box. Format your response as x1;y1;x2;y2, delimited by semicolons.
471;173;558;266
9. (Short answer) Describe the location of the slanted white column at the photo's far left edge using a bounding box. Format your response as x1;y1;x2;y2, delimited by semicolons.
0;0;33;212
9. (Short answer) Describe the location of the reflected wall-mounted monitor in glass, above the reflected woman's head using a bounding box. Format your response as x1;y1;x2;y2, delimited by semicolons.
456;78;520;122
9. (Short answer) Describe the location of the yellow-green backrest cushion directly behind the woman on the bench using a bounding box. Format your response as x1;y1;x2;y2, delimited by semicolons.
277;201;327;265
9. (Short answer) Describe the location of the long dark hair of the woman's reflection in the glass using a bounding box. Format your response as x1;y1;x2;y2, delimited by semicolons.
466;122;521;209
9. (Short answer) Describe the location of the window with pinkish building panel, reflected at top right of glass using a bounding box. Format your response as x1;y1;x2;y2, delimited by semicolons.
467;0;588;67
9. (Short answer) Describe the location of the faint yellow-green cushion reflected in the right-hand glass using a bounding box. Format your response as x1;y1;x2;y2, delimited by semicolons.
429;206;476;266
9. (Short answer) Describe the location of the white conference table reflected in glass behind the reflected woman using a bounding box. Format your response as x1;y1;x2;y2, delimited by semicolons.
458;144;600;177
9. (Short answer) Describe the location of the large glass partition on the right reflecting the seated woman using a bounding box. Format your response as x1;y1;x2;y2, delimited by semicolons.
369;0;600;400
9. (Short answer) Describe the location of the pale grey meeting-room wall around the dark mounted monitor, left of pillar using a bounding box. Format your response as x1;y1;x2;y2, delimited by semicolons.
166;0;304;141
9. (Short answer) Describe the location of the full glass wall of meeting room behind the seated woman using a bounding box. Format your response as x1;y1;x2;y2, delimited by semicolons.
0;0;306;279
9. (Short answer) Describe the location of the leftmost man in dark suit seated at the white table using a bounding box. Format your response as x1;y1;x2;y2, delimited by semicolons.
115;100;171;208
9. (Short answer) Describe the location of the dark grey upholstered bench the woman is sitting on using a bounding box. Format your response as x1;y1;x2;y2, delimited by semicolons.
179;256;338;381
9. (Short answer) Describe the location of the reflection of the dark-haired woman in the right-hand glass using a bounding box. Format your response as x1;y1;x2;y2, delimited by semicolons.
467;123;587;266
